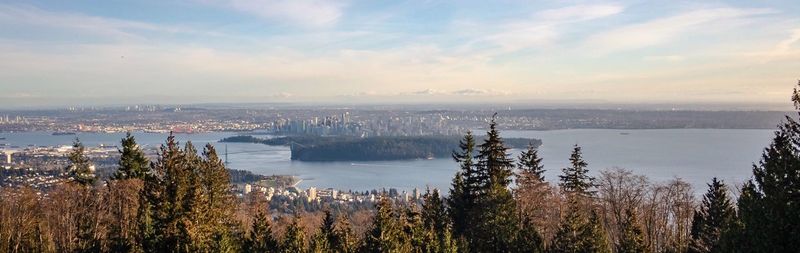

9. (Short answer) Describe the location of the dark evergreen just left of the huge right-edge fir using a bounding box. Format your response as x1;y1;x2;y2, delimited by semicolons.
689;178;736;253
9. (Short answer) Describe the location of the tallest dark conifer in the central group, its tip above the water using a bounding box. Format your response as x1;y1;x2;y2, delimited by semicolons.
468;114;519;252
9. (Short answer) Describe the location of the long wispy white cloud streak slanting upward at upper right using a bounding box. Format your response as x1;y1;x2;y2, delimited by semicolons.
586;8;775;53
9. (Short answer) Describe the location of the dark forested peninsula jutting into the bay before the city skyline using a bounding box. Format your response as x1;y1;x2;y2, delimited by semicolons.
220;135;542;162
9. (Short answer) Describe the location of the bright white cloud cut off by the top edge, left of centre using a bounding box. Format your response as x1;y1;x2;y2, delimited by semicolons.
220;0;345;27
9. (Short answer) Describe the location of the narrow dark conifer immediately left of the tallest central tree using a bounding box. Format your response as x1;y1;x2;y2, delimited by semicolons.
447;131;480;241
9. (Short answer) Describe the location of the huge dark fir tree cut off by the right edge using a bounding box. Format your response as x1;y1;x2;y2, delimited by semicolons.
728;81;800;252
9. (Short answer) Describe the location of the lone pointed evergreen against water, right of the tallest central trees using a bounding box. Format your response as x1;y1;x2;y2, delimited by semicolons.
559;144;595;197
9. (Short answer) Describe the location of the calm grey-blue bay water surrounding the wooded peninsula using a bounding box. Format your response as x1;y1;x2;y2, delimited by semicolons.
0;129;773;193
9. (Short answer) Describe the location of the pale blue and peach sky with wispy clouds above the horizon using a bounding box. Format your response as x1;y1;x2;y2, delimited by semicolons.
0;0;800;108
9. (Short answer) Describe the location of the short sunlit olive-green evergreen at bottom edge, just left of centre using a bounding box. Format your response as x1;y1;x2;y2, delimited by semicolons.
360;196;408;252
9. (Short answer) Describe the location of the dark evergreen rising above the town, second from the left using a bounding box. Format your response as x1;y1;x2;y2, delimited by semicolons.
111;132;150;180
